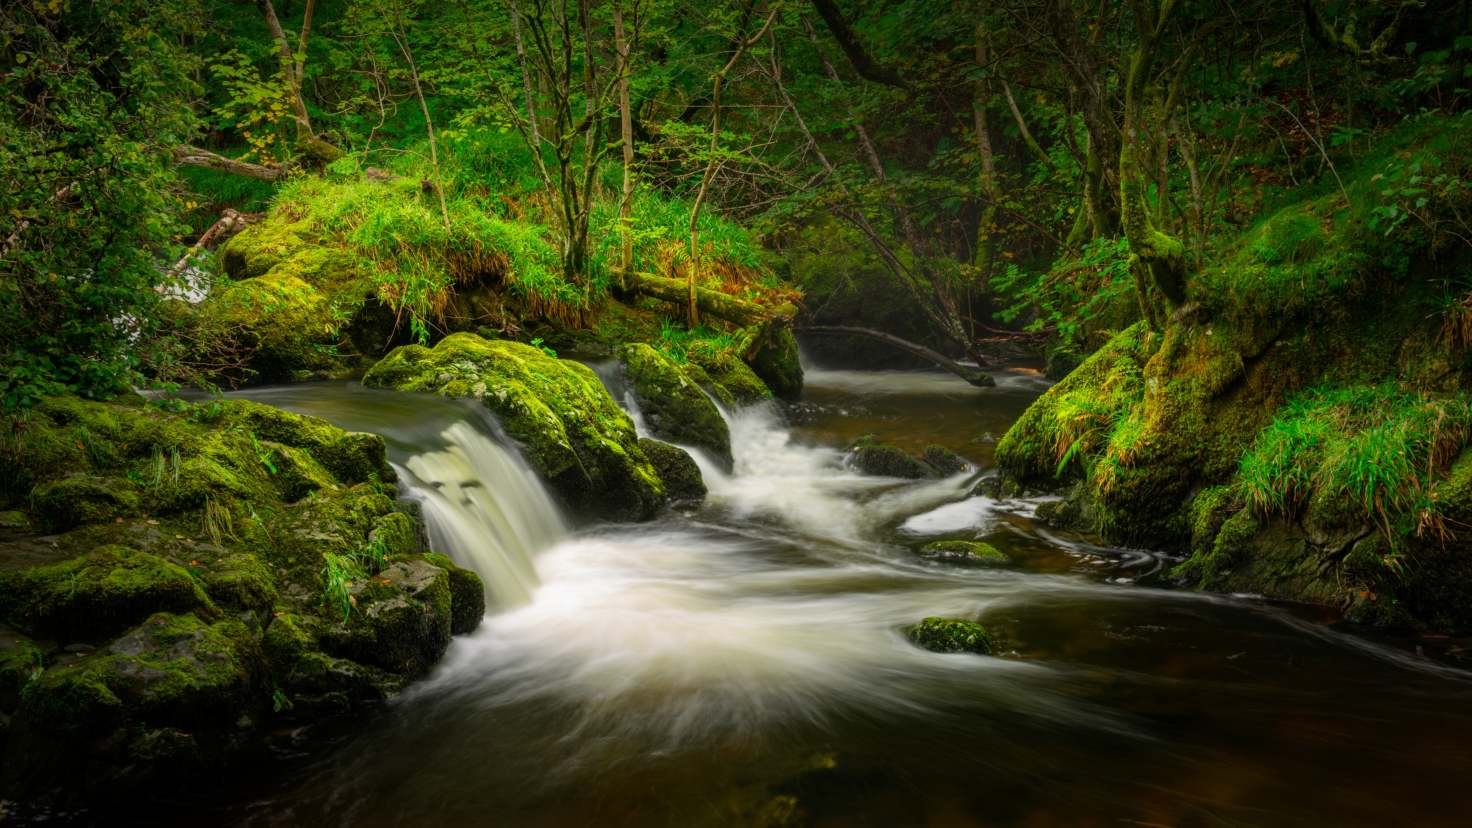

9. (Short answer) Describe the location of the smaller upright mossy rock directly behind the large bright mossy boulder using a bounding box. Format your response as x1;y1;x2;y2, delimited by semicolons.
618;342;732;469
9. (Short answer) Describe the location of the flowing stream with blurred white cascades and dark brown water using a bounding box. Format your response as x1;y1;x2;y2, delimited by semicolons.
209;360;1472;827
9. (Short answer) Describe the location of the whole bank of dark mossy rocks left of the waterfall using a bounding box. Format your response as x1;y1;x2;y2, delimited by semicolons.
0;398;484;801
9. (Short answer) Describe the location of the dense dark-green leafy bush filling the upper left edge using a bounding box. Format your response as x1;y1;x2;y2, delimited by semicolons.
0;0;200;411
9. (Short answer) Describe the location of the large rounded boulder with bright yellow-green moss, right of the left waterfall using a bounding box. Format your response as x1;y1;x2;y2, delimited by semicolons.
364;333;664;520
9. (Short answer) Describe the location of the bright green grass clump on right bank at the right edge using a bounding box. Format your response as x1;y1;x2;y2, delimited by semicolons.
1236;385;1472;548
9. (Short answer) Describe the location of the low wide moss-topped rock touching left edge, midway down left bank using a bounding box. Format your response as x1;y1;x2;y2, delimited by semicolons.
0;545;218;642
